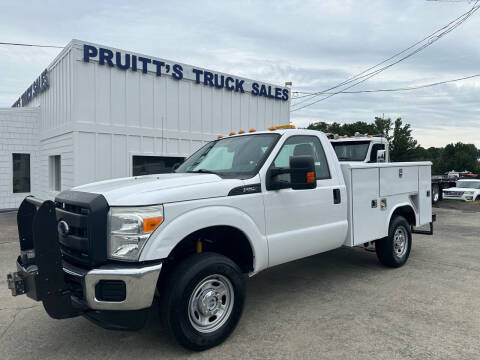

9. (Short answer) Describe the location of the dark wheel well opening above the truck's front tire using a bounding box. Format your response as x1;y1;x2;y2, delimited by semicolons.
163;226;253;273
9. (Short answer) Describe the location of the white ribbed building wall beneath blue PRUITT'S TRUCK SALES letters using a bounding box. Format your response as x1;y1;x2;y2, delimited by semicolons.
66;41;290;185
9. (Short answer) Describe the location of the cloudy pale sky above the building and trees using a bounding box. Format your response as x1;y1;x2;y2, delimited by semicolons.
0;0;480;147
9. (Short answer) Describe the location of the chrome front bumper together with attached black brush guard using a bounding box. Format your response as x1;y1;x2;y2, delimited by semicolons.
7;198;162;328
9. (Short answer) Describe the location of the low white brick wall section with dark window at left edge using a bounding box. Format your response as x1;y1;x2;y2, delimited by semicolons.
0;108;40;209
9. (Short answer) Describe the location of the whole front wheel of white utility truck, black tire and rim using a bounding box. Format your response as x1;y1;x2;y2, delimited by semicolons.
160;252;245;351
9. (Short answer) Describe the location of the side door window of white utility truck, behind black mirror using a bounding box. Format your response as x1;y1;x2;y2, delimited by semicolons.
271;135;331;183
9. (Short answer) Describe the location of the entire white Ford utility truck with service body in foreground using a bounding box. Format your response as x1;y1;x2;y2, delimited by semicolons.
8;129;432;350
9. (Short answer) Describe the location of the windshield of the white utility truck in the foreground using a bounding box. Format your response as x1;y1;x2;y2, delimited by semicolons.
175;133;280;179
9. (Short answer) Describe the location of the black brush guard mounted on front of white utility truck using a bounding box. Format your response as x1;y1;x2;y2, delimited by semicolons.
7;197;88;319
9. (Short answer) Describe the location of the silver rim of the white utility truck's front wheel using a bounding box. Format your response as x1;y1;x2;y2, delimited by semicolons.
188;274;234;333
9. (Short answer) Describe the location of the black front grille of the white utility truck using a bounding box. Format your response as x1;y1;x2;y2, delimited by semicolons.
55;191;108;268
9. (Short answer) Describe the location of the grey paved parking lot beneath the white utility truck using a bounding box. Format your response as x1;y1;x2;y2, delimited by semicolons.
0;206;480;360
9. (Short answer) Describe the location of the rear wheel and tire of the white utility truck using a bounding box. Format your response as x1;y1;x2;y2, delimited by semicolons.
375;216;412;268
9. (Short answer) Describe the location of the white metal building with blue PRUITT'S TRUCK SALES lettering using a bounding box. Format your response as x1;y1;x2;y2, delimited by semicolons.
0;40;290;209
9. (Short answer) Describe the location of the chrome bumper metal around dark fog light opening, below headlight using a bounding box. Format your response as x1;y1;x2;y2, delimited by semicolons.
63;263;162;310
